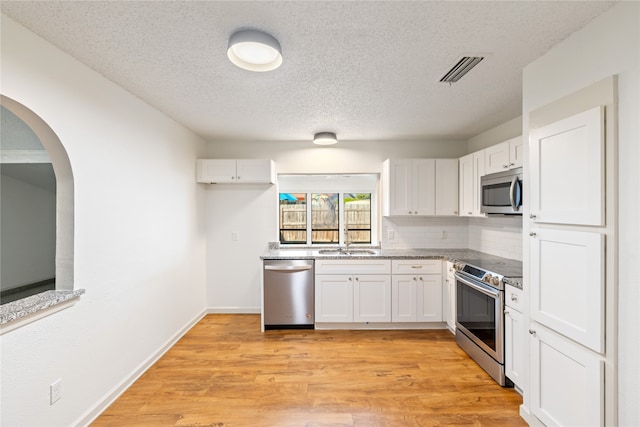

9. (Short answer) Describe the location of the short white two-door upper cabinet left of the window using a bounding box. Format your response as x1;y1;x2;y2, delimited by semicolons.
196;159;276;184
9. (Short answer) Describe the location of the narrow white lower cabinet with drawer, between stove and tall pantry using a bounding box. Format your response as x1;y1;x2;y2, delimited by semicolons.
504;286;528;390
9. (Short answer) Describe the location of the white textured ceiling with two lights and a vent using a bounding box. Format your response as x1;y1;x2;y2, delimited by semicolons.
1;1;614;141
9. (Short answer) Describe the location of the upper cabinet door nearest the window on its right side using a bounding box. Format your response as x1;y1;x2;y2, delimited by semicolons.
386;159;414;216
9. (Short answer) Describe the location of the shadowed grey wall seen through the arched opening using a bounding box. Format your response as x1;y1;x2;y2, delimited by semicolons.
0;174;56;290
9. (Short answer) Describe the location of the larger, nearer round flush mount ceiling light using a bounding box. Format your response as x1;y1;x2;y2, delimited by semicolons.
227;30;282;72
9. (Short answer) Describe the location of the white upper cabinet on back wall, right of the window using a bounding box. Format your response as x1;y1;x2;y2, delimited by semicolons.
382;159;458;216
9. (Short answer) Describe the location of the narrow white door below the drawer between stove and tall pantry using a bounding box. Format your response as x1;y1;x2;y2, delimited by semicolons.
504;307;528;390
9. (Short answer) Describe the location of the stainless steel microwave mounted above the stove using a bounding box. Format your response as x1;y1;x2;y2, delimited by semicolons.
480;168;522;215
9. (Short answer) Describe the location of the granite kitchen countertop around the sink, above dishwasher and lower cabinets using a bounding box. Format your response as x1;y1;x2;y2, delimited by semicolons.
260;247;522;289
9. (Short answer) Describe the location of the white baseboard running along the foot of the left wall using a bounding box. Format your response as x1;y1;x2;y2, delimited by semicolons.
72;310;207;426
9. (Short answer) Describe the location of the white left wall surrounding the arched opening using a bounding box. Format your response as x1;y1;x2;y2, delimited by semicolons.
0;15;205;426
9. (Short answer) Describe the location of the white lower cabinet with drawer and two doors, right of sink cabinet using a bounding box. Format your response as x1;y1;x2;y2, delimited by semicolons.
391;260;443;322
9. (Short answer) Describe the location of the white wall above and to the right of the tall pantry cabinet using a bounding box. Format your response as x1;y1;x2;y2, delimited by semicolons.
523;2;640;426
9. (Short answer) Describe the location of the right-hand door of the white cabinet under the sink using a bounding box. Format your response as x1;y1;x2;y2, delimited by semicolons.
353;274;391;322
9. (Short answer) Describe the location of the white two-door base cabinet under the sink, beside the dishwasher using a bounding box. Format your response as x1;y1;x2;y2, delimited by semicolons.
315;260;391;323
